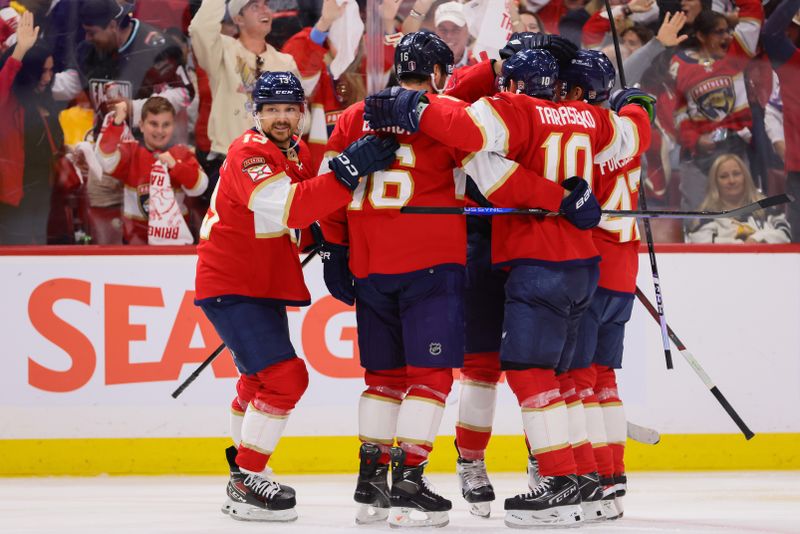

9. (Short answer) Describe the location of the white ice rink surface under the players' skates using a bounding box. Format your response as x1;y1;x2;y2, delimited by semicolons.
0;471;800;534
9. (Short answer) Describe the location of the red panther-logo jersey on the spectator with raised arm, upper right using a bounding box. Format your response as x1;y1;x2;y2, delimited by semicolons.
670;0;764;154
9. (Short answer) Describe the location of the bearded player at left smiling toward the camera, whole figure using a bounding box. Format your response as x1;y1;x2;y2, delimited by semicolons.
195;72;397;521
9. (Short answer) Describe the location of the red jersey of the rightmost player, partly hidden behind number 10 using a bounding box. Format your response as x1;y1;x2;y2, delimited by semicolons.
592;156;642;293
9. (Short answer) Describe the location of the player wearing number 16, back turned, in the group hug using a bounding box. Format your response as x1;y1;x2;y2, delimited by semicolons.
321;32;467;526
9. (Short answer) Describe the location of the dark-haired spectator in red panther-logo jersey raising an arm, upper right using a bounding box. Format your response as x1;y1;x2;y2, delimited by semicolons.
670;0;764;213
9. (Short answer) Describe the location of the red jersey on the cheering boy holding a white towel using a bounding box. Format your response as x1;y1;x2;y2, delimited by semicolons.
97;118;208;245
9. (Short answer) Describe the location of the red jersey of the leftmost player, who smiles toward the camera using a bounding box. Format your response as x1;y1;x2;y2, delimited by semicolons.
195;131;352;306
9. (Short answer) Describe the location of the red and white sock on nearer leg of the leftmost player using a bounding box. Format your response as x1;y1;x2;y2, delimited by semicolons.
236;358;308;473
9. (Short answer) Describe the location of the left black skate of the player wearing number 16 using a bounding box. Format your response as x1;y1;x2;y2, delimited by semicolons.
353;443;389;525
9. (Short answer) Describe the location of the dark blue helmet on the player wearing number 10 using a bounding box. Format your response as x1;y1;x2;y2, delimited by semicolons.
502;49;558;99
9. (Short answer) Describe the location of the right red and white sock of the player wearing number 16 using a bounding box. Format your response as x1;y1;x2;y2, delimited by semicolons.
397;365;453;467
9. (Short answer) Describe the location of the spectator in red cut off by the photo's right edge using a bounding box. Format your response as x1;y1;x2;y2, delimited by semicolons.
763;0;800;243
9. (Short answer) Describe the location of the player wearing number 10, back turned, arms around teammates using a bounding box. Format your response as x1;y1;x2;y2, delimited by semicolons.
366;50;654;526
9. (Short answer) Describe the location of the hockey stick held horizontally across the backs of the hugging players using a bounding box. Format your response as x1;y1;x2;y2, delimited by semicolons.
400;194;794;219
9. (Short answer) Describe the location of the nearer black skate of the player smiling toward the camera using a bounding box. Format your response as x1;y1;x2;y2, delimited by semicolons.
228;473;297;521
